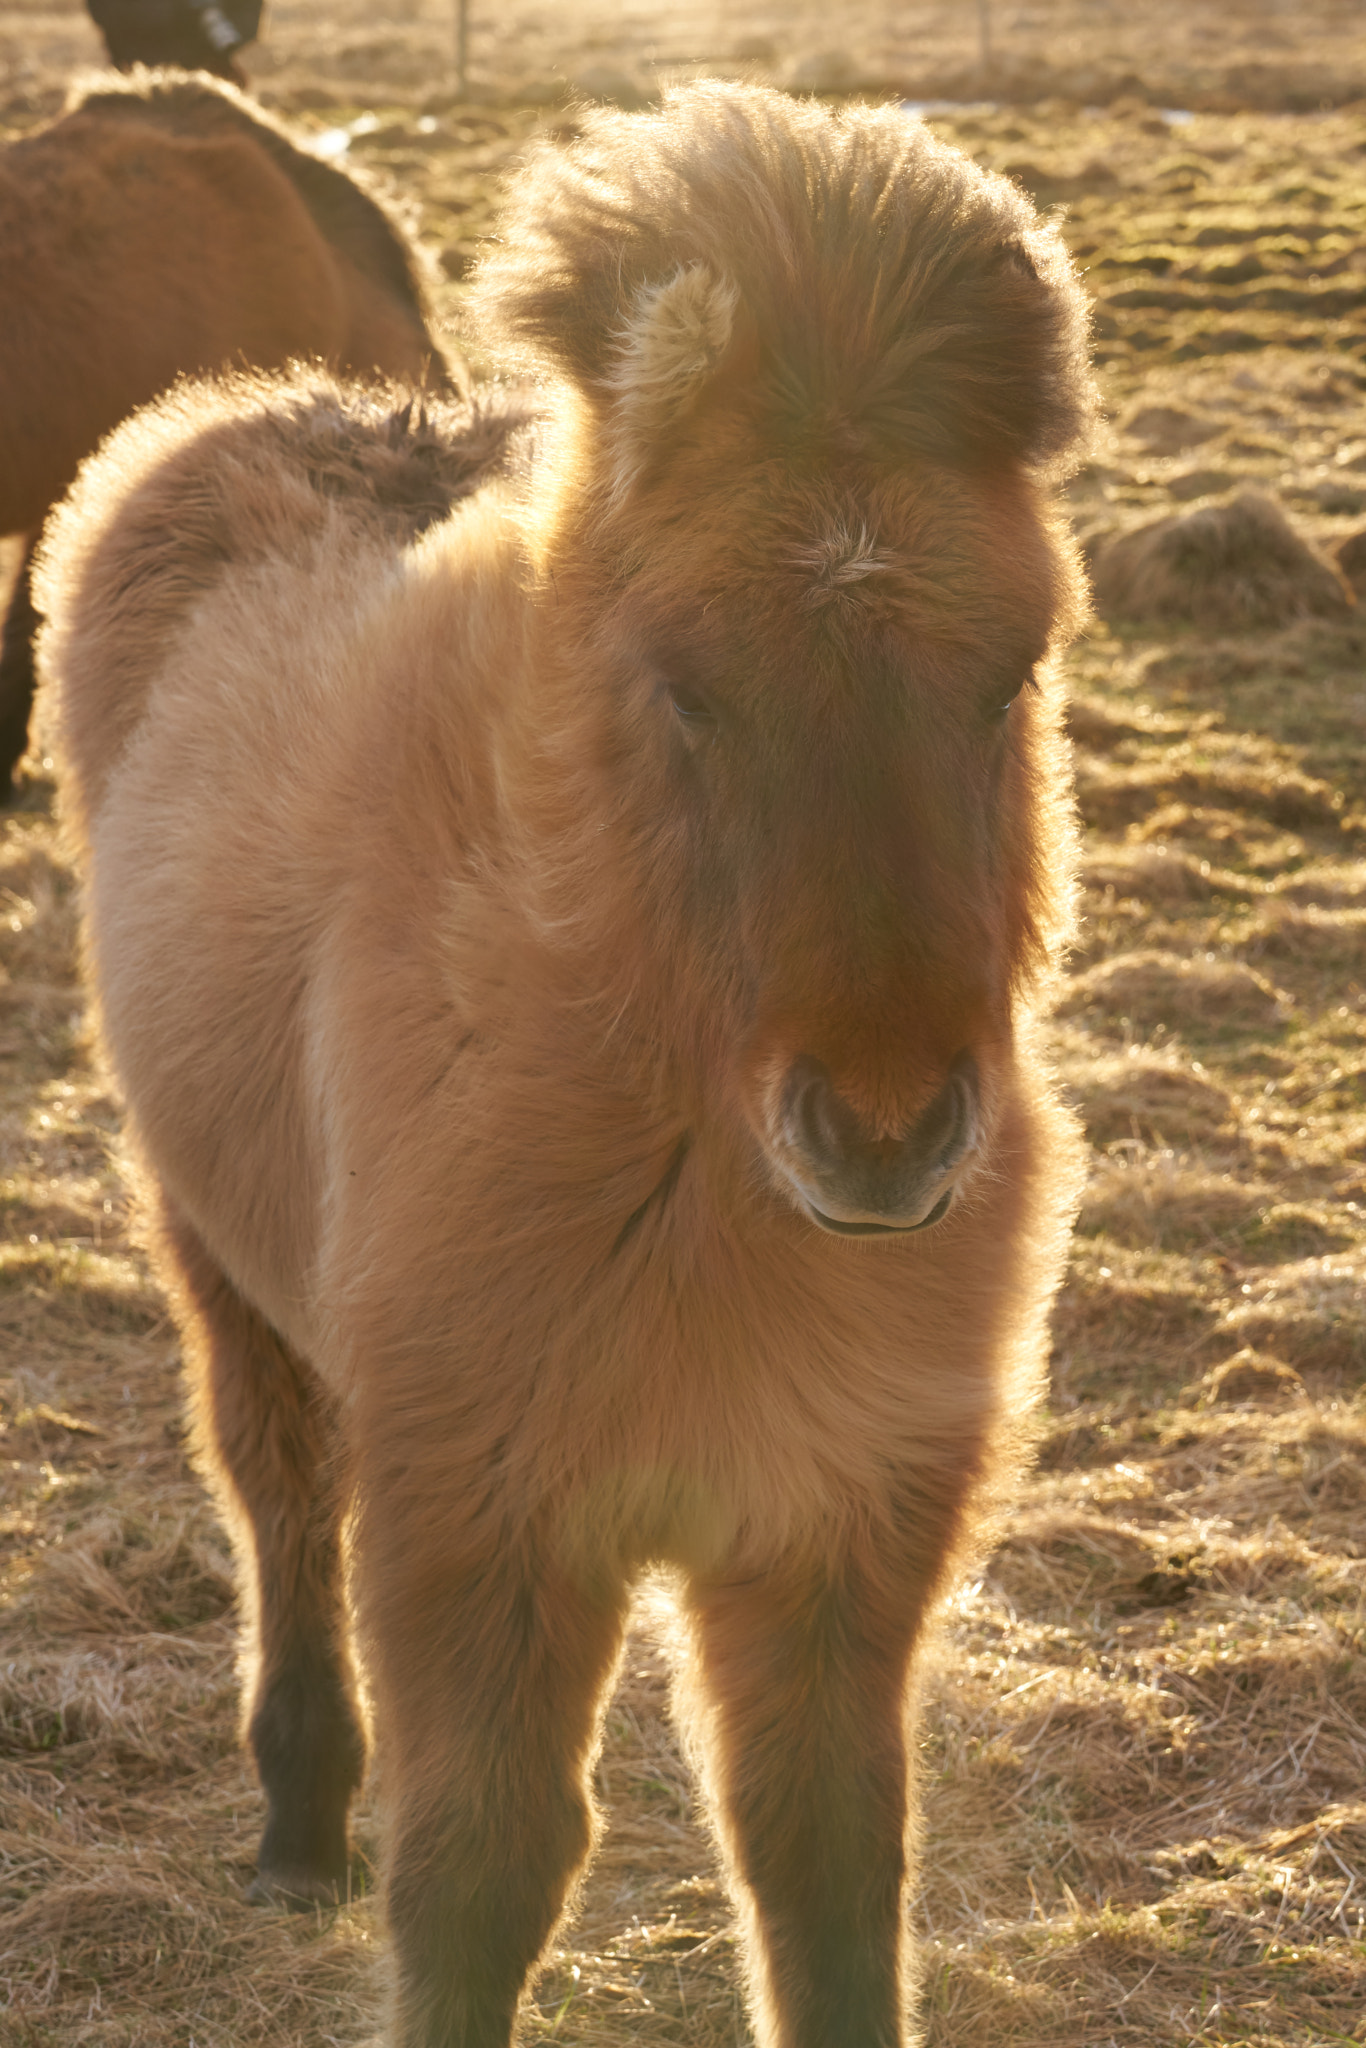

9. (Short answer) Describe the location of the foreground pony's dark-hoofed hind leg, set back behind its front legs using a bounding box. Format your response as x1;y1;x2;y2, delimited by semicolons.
158;1204;365;1905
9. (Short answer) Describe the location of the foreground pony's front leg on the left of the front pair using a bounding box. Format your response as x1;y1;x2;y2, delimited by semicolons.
360;1499;625;2048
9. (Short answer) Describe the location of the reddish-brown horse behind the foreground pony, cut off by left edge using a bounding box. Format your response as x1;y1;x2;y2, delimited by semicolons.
0;72;451;803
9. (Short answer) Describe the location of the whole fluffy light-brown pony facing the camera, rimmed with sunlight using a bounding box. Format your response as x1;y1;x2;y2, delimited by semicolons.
39;86;1090;2048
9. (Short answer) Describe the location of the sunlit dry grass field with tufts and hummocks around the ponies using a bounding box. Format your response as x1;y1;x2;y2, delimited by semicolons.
0;0;1366;2048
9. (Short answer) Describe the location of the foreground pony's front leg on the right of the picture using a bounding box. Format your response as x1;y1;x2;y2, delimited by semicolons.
688;1546;958;2048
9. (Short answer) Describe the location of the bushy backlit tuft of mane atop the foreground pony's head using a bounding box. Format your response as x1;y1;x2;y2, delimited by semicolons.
475;84;1094;469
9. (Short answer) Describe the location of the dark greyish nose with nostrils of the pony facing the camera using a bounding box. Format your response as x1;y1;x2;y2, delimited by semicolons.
780;1053;979;1237
